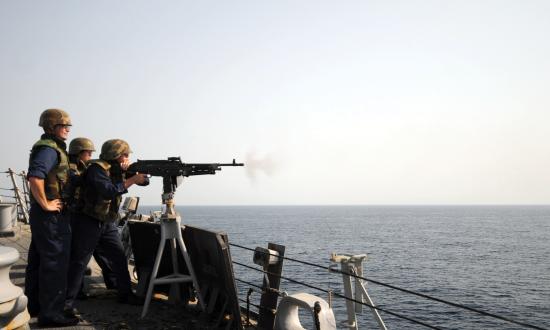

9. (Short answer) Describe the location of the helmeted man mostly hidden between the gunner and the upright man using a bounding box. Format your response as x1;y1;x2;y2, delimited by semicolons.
65;137;116;299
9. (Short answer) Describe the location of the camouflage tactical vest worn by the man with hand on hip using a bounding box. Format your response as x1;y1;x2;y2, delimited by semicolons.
30;136;69;201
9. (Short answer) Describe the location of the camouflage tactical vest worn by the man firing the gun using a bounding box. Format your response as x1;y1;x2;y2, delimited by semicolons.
82;159;124;222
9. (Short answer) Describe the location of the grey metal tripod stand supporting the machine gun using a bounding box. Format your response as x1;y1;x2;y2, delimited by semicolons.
141;177;205;318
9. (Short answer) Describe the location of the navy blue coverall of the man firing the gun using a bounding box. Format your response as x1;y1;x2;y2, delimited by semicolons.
66;164;131;307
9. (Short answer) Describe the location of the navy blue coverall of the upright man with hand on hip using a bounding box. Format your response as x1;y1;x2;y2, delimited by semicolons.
25;147;71;320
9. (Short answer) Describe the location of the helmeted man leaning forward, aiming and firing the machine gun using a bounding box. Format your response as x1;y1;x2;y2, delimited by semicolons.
66;139;147;310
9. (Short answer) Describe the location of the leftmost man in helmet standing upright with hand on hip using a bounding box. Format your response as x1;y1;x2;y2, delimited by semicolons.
25;109;78;326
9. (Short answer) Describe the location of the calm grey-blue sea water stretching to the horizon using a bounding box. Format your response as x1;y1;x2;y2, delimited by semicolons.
140;206;550;329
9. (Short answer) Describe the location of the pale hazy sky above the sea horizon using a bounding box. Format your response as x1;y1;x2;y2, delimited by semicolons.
0;0;550;205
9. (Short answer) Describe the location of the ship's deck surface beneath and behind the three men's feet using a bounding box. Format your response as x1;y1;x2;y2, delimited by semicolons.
0;224;203;329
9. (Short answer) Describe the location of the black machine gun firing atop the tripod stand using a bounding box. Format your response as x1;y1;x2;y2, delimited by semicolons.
127;157;244;215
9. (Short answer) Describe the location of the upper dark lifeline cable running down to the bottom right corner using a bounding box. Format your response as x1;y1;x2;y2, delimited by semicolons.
229;243;548;330
